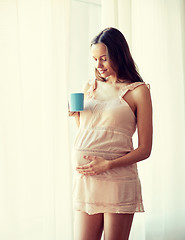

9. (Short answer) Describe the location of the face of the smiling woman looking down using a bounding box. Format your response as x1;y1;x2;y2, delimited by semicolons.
91;43;116;78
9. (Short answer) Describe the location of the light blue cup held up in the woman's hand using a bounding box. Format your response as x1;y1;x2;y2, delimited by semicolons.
70;93;84;112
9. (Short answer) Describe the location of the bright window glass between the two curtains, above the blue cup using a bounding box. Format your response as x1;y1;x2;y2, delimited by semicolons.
69;0;101;92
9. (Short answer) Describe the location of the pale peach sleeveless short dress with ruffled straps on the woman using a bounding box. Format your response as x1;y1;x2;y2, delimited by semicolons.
72;82;148;214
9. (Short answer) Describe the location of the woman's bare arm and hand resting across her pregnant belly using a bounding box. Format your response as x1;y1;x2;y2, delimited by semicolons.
77;85;153;175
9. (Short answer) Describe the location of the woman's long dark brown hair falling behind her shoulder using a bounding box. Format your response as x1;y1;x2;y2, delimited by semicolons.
91;28;143;82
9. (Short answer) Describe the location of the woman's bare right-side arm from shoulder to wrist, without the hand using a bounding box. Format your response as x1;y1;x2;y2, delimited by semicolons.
110;85;153;168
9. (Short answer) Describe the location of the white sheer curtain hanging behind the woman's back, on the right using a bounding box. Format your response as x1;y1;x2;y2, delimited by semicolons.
102;0;185;240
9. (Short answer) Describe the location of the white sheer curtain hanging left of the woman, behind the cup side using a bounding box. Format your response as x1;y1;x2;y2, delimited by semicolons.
0;0;72;240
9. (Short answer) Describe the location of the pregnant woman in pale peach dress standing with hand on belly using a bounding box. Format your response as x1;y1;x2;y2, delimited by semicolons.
69;28;152;240
